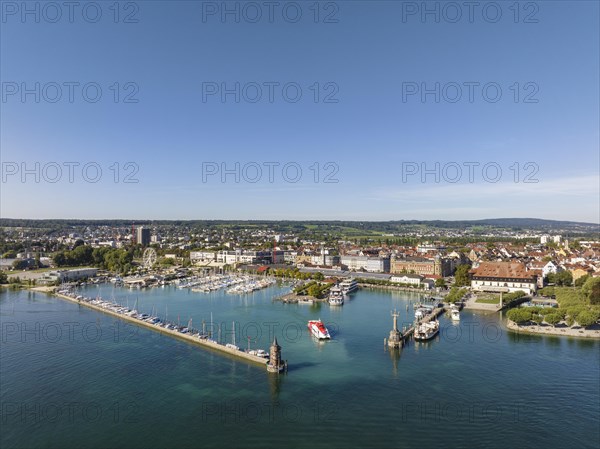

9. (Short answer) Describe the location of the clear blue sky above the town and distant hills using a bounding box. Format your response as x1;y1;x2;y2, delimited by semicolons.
0;1;600;222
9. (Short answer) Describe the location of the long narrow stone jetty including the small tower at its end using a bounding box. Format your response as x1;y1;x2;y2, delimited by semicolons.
54;291;287;372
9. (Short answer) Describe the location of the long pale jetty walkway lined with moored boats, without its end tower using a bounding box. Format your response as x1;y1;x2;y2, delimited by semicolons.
54;292;278;368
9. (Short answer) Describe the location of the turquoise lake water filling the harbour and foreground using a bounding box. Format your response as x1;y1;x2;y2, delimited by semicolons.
0;285;600;448
